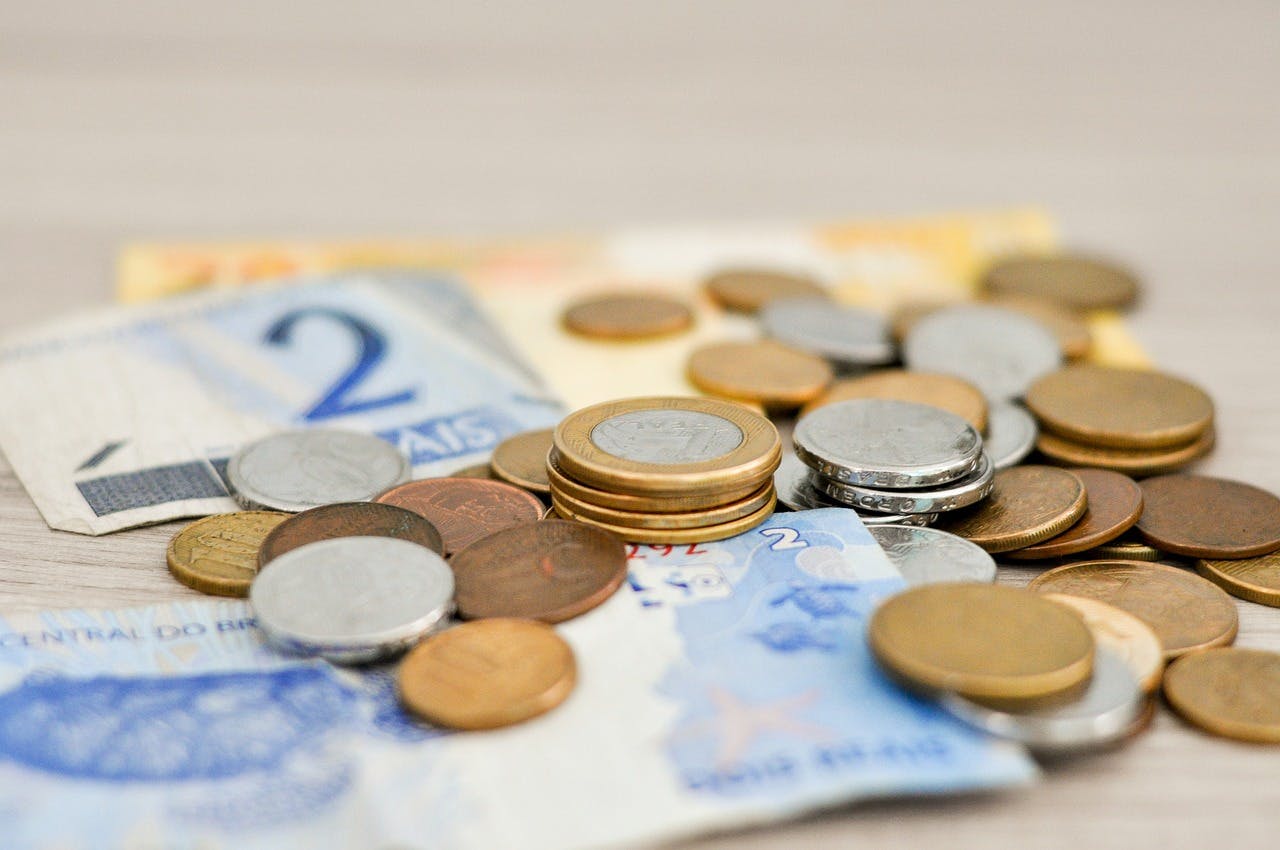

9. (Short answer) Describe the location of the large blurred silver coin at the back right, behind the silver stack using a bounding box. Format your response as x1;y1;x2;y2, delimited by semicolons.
902;305;1062;401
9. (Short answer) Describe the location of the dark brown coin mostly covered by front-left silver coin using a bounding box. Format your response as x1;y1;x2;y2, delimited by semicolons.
257;502;444;568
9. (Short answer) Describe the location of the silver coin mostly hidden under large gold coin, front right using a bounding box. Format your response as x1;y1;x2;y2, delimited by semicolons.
941;646;1146;754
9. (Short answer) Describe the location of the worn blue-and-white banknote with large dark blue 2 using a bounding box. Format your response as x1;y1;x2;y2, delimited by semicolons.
0;273;563;534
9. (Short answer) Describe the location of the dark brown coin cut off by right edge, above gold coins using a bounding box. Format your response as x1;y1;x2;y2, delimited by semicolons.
1138;475;1280;558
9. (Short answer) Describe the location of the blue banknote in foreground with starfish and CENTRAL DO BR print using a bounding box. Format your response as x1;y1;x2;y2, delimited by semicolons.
0;508;1034;850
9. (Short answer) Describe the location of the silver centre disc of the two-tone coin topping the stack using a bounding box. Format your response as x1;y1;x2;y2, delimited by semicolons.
591;410;745;463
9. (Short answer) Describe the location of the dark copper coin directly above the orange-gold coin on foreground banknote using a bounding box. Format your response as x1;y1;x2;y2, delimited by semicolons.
449;520;627;622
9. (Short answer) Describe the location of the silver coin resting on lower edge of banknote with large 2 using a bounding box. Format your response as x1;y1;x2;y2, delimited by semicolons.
227;429;412;513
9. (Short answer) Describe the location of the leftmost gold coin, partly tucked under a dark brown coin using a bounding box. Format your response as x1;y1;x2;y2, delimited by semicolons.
165;511;292;597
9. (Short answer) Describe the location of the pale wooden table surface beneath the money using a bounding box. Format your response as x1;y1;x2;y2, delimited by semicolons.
0;0;1280;850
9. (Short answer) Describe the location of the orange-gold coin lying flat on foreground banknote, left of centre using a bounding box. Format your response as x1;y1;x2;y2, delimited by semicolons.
397;618;577;730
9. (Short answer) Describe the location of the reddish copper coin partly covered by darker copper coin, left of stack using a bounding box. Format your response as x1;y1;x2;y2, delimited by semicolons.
374;479;545;556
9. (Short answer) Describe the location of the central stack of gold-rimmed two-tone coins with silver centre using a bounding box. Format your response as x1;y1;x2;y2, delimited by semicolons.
547;397;782;543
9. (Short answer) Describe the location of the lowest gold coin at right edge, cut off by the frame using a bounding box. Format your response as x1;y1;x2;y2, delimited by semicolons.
1165;648;1280;744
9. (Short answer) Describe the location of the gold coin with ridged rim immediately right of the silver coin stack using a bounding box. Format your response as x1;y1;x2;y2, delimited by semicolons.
937;466;1088;553
